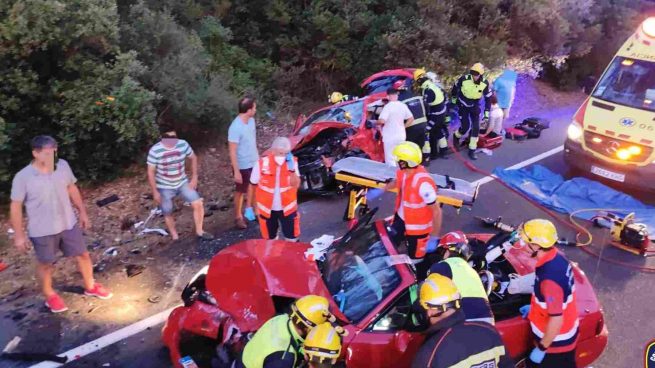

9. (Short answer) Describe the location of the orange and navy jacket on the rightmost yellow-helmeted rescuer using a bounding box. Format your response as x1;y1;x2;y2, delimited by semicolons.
528;250;579;352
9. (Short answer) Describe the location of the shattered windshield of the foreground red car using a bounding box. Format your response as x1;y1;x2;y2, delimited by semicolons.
323;224;400;323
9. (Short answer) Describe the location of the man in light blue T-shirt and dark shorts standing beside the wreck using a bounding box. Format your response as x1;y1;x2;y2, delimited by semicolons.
227;97;259;229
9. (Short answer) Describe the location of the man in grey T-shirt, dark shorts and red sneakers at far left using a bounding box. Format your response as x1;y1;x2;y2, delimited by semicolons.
10;136;112;313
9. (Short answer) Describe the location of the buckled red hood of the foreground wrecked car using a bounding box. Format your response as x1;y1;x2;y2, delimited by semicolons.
206;240;346;332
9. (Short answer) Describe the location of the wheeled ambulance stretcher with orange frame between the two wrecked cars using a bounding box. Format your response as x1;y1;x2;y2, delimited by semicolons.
332;157;479;221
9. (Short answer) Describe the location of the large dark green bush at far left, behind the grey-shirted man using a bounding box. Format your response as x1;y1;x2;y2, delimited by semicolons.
0;0;155;197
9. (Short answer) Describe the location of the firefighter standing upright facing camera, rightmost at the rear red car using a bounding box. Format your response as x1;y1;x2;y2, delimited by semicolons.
450;63;491;160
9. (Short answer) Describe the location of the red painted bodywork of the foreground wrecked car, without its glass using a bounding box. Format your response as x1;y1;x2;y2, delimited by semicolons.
162;222;607;368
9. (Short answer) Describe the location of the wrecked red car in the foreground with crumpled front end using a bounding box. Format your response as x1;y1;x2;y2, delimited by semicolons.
162;211;608;368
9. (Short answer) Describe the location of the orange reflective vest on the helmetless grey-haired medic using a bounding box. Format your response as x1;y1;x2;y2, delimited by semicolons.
255;155;298;218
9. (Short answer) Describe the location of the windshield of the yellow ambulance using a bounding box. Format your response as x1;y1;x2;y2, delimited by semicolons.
593;56;655;111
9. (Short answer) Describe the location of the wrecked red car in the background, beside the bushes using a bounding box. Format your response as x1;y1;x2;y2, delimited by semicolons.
289;69;414;194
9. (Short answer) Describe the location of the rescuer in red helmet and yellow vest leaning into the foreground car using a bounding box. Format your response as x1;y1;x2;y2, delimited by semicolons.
430;231;495;325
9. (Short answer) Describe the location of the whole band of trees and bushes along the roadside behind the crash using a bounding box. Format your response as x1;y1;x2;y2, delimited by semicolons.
0;0;653;198
